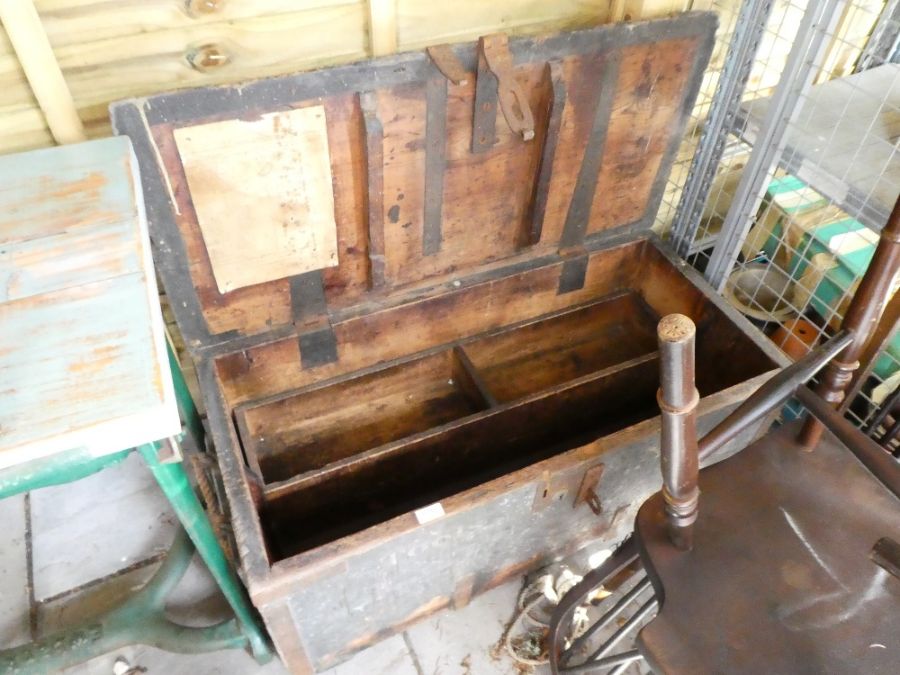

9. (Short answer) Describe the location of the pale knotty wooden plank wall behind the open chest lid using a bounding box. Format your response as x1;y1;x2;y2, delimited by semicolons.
0;0;696;153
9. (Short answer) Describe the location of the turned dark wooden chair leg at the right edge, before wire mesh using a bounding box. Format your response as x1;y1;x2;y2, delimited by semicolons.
798;194;900;450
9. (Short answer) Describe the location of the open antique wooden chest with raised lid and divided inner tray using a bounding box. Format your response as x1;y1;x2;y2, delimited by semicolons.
112;13;781;673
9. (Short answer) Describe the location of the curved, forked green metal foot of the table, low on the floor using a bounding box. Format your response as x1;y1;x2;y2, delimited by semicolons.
0;530;248;675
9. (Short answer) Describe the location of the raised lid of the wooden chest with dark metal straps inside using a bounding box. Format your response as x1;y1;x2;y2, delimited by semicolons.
112;13;716;368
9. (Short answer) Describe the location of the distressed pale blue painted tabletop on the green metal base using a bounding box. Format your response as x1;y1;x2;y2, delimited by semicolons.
0;138;180;468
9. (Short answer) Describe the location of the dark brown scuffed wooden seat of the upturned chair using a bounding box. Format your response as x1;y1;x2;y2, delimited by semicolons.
635;425;900;675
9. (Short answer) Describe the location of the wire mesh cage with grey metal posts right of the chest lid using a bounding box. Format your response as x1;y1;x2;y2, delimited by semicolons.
657;0;900;454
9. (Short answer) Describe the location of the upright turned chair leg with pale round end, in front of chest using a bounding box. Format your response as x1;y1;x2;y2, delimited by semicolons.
656;314;700;551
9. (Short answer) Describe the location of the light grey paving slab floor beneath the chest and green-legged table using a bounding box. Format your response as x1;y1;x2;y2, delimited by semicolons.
0;446;648;675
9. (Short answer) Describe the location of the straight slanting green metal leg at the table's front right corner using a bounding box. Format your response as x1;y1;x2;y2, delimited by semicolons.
138;443;272;663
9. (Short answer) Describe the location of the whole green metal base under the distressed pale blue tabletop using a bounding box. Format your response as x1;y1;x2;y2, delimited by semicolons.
0;346;272;675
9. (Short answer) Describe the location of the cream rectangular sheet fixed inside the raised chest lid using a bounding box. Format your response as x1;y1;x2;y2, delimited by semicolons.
175;105;338;293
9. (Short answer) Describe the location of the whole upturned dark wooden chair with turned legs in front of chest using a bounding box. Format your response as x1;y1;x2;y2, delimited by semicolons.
551;193;900;675
